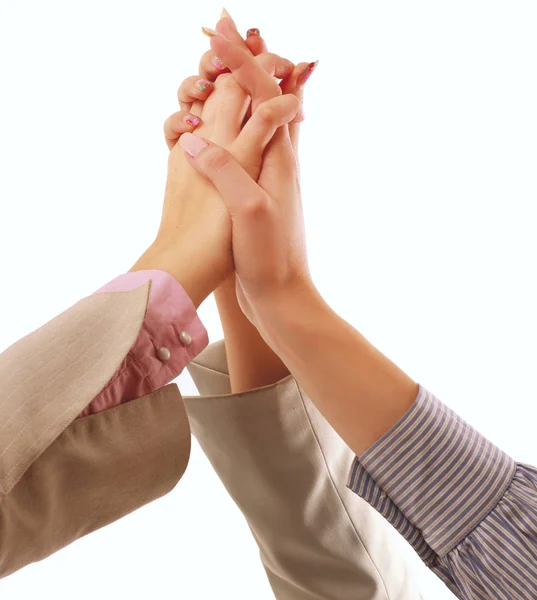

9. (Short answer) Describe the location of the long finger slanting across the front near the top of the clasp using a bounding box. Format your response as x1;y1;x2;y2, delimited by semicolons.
206;35;292;111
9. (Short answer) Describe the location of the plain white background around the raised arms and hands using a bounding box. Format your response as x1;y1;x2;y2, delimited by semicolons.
0;0;537;600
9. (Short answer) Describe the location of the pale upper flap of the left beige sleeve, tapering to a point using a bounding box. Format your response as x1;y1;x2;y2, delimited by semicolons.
0;282;150;498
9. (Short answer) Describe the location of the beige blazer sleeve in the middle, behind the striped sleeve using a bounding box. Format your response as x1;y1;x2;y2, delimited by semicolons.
185;342;420;600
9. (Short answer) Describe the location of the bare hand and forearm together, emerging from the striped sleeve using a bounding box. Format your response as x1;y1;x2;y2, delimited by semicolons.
176;28;418;456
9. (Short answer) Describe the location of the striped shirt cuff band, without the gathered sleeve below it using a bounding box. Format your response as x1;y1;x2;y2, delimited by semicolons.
347;385;516;563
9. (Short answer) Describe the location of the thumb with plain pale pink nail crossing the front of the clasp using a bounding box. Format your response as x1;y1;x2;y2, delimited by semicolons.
179;133;269;223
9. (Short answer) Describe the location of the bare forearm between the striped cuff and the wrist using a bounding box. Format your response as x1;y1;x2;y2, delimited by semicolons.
254;286;418;455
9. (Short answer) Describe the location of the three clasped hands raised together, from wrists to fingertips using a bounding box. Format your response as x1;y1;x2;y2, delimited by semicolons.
132;15;315;332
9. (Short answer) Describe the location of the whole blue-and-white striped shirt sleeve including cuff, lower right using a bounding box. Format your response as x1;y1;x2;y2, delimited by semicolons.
348;385;537;600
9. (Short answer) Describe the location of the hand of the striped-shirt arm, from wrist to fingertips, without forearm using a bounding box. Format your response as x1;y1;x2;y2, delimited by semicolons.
180;35;315;326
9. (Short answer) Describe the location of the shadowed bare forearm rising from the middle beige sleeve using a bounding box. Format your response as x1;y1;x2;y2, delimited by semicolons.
215;275;289;393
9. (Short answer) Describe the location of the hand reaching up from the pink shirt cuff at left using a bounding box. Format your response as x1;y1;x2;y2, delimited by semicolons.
132;19;294;306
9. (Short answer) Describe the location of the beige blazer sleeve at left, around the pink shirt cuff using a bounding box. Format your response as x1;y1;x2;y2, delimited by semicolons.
0;281;190;577
